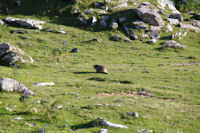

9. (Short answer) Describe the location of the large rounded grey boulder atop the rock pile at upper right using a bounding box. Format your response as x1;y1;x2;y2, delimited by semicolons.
136;2;164;26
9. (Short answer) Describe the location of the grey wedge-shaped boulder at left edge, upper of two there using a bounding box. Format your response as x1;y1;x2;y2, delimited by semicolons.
0;43;34;65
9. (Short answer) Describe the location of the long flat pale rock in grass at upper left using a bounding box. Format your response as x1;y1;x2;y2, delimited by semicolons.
5;17;45;30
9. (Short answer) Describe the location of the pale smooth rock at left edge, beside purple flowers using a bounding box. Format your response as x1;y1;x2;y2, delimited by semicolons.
0;78;34;95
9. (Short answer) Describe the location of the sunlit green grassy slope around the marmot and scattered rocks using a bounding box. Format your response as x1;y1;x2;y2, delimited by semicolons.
0;0;200;133
